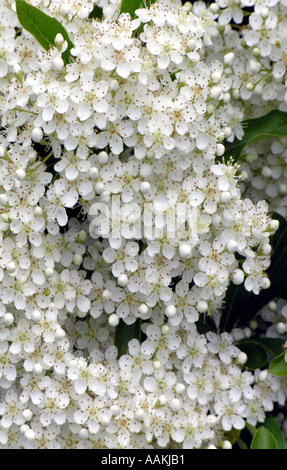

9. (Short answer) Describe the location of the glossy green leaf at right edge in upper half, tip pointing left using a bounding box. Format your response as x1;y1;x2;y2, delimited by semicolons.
223;109;287;162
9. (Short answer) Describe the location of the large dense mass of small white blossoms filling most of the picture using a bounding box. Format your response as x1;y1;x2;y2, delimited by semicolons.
0;0;287;449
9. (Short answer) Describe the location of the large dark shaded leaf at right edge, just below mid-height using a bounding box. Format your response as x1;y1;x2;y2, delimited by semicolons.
220;214;287;331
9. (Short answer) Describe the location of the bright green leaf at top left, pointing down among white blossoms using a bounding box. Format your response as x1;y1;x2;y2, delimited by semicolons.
16;0;74;64
